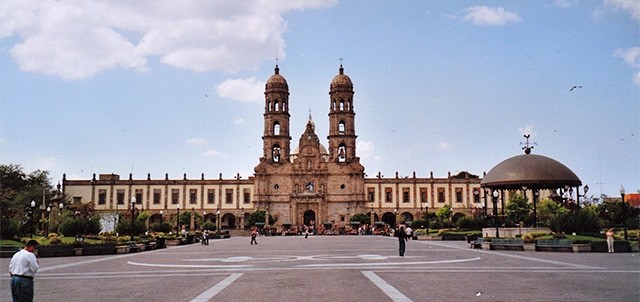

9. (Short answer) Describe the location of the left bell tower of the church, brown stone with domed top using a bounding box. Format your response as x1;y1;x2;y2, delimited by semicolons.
262;65;291;163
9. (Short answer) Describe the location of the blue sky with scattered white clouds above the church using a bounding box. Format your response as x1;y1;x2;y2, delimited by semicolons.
0;0;640;196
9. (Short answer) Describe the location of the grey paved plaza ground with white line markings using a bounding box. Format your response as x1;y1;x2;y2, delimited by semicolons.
0;236;640;302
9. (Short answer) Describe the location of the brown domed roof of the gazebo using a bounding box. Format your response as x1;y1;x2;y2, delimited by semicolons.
480;154;582;189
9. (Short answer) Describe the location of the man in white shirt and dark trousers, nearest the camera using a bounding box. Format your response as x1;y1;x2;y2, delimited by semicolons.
9;240;40;302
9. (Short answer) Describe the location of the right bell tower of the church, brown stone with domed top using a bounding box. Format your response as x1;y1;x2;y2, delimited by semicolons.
327;64;359;163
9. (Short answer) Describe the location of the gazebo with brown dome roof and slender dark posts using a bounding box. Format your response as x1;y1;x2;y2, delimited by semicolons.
480;144;588;237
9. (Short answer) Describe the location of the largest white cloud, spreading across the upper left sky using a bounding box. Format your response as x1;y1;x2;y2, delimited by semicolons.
0;0;335;80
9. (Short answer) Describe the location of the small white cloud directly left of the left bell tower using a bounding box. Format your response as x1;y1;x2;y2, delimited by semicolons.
216;77;265;103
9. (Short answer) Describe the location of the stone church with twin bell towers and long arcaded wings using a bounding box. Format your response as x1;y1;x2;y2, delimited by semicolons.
63;65;487;229
